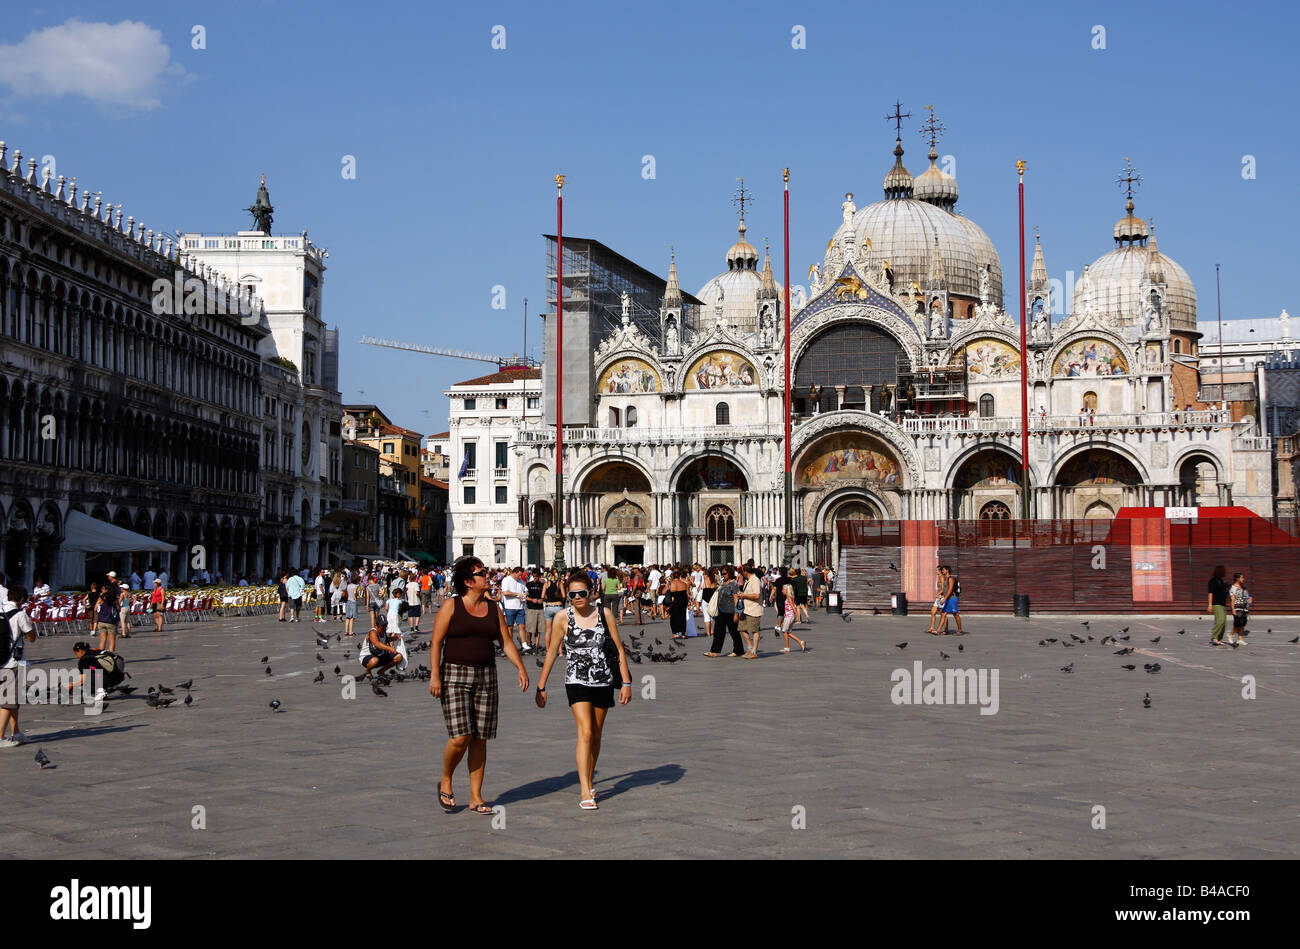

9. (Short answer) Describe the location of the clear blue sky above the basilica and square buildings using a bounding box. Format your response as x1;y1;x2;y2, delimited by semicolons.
0;0;1300;433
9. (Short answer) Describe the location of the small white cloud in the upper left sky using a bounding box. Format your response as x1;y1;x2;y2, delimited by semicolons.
0;18;186;109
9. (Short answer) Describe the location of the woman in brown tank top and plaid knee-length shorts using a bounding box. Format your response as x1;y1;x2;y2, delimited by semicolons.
429;556;528;814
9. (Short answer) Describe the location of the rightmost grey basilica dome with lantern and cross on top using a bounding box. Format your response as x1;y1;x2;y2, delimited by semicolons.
1070;198;1196;333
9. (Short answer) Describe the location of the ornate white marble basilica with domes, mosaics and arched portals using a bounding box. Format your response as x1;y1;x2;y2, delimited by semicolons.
515;126;1273;563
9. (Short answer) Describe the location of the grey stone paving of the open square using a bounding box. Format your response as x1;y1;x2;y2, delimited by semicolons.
0;611;1300;858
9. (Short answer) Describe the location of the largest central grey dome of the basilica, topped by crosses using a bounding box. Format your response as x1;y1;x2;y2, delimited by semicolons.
822;137;1002;302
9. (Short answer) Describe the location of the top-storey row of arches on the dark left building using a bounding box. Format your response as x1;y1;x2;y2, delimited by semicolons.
0;257;261;415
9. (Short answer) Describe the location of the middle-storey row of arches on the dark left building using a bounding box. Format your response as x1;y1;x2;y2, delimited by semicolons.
0;376;257;494
